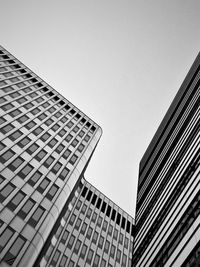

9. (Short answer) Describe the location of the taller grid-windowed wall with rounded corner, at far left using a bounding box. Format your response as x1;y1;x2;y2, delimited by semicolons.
0;47;101;266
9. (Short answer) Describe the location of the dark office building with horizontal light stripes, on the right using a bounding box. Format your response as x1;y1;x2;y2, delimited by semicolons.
133;54;200;267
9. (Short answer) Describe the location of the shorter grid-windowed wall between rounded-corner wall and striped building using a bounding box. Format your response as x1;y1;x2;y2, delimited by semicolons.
40;179;133;267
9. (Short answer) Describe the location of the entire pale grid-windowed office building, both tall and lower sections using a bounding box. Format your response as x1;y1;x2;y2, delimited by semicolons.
0;47;133;267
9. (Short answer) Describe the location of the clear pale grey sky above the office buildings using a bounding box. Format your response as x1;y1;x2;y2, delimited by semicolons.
0;0;200;216
